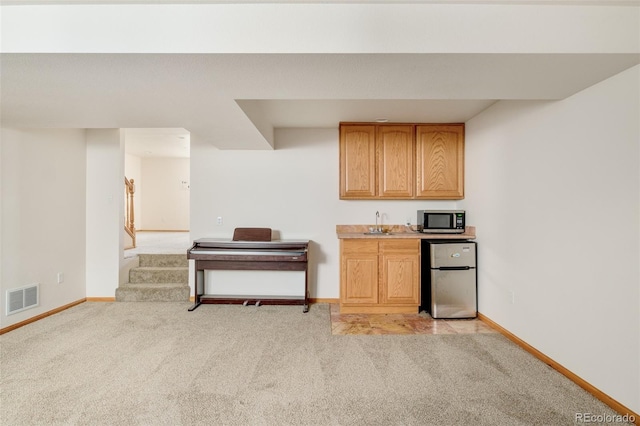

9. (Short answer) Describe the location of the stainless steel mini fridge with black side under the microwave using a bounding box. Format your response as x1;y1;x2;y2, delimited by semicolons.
422;241;478;318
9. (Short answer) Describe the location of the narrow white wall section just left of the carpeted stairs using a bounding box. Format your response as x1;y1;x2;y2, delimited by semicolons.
86;129;124;298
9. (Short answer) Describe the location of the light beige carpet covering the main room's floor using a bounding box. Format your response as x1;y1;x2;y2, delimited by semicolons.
0;302;614;426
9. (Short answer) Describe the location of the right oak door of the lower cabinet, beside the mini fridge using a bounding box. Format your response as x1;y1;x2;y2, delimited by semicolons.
380;239;420;305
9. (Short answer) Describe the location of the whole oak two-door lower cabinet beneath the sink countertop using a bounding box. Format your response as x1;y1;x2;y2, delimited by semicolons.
340;239;420;313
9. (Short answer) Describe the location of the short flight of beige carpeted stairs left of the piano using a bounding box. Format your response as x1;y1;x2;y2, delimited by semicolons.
116;254;190;302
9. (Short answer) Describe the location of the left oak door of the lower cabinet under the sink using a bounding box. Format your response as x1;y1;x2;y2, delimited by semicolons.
340;240;378;304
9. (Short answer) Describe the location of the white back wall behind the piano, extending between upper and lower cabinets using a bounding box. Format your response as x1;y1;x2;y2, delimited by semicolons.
191;129;455;298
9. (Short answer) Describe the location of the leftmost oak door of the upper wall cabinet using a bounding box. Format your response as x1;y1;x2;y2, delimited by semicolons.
340;125;376;198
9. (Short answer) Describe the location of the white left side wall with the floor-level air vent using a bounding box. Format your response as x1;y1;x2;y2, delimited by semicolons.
0;129;86;327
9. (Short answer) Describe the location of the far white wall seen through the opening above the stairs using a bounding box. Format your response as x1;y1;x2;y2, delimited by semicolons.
136;157;190;231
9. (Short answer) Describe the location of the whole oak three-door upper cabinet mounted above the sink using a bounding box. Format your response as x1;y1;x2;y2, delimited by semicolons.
340;123;464;200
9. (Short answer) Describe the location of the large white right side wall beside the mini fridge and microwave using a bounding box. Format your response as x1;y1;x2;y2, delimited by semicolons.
459;66;640;412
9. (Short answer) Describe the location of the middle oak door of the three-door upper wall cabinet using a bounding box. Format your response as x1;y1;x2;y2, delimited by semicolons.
376;125;415;198
